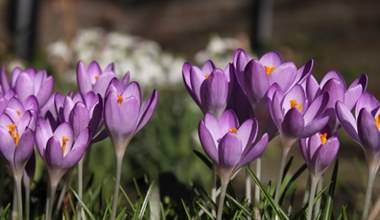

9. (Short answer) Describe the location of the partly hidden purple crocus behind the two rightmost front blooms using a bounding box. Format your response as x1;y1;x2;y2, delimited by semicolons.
306;71;368;132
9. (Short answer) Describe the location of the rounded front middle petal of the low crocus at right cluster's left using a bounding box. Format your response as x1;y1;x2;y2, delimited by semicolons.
219;133;243;168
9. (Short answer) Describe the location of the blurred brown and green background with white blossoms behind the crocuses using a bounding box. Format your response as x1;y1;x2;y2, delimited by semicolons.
0;0;380;217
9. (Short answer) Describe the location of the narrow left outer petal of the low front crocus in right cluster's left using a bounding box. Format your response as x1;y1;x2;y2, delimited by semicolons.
198;120;219;164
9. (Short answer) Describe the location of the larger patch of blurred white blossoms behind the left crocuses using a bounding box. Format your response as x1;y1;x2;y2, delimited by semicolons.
47;28;184;86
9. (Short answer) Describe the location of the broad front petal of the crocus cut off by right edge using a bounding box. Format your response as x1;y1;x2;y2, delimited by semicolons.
358;109;380;152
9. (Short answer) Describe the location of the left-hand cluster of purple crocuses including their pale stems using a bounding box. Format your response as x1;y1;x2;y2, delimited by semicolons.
0;61;158;219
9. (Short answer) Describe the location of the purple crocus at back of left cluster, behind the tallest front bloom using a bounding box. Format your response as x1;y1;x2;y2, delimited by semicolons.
77;61;116;98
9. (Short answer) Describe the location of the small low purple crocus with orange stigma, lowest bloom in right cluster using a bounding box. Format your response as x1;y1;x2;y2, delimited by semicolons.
300;132;339;179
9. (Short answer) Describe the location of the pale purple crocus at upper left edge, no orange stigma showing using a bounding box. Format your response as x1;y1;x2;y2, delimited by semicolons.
0;67;54;107
